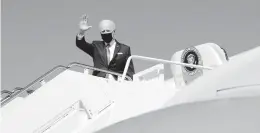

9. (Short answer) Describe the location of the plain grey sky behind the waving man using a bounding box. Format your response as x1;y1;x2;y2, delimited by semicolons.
1;0;260;90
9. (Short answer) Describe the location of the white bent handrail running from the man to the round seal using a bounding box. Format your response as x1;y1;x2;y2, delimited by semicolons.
119;55;213;81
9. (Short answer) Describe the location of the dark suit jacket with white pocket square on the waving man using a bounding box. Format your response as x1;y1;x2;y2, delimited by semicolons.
76;37;135;79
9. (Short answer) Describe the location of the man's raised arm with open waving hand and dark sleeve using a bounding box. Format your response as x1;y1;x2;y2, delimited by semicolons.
76;15;94;57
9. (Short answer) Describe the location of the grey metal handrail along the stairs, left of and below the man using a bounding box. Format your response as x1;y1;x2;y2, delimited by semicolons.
1;62;132;106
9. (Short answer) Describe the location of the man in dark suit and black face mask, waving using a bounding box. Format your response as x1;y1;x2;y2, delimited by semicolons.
76;15;135;80
